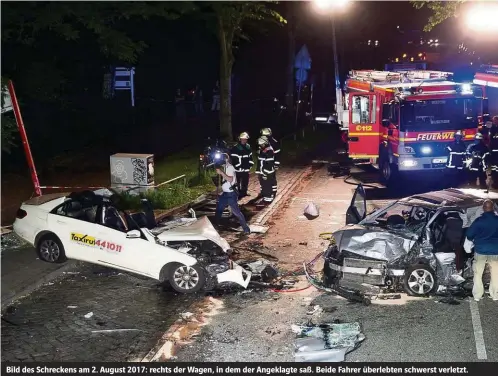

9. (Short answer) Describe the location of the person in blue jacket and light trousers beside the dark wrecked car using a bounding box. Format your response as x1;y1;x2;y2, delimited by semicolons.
466;199;498;301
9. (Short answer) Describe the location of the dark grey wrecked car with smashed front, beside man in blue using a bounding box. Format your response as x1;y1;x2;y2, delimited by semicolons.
324;185;498;296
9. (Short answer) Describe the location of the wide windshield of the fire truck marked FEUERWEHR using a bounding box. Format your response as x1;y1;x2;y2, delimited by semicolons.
400;98;478;131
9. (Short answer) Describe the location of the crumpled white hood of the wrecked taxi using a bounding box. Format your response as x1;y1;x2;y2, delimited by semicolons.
152;217;230;252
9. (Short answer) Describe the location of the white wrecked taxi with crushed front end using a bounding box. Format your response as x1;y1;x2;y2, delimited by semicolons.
14;190;251;293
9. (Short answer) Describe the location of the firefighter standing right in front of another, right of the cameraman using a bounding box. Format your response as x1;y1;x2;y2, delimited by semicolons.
256;136;276;205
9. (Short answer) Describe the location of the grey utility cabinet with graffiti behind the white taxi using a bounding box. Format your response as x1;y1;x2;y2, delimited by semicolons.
110;153;154;194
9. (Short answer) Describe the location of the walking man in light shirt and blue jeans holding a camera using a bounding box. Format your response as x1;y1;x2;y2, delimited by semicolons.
214;154;251;234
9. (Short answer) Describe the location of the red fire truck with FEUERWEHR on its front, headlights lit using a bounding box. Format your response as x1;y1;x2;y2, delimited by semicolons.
342;70;483;186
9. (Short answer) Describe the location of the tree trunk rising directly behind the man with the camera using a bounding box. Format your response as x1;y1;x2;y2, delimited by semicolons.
218;17;233;141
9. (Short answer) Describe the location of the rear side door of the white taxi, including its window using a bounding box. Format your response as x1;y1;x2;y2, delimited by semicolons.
47;200;100;261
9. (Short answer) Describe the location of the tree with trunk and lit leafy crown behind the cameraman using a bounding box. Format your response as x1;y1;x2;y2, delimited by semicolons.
199;1;287;140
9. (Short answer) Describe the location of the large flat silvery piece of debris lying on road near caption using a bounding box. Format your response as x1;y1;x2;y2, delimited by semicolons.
291;322;365;362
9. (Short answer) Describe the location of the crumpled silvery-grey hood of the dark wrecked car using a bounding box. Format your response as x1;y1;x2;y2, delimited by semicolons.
333;225;418;262
